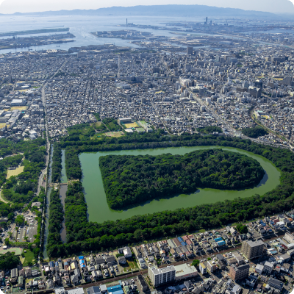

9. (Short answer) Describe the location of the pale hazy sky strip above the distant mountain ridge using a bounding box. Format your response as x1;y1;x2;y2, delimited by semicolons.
0;0;294;14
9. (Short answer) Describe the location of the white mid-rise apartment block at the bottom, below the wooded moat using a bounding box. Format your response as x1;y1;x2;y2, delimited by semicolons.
148;265;176;287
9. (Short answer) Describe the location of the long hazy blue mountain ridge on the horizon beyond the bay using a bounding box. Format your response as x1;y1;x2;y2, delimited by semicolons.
0;5;277;18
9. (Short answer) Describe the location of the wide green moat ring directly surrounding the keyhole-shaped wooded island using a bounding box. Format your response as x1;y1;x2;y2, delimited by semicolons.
79;146;280;222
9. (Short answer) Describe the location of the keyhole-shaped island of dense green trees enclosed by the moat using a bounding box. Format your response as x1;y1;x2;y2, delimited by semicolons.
99;149;264;209
